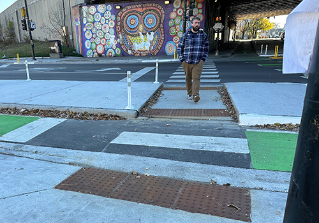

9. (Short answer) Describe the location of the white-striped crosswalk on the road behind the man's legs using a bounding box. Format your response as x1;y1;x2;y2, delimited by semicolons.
166;62;220;83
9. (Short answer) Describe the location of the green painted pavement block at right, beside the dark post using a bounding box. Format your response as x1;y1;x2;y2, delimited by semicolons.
246;131;298;171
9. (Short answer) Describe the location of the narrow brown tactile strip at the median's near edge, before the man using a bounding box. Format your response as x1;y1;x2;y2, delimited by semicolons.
143;109;230;117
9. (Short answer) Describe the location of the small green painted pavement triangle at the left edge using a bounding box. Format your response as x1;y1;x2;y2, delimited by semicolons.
0;115;39;136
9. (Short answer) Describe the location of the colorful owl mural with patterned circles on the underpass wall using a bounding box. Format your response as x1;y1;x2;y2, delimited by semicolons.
73;0;205;57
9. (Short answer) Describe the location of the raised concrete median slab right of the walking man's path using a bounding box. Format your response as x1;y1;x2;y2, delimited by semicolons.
225;83;307;125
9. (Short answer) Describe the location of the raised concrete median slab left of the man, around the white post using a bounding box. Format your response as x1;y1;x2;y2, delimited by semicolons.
0;81;162;118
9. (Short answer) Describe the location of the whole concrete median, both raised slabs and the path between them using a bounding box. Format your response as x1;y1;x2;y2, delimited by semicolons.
0;80;306;125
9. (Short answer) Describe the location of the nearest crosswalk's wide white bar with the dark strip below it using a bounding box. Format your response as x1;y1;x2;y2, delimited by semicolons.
107;131;252;169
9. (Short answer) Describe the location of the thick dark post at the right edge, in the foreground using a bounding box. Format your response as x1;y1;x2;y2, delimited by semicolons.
284;22;319;223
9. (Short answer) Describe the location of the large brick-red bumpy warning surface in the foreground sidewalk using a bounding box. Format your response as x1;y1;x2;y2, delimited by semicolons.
55;168;251;222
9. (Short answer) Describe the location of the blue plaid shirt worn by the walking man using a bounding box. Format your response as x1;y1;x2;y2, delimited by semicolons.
177;29;209;64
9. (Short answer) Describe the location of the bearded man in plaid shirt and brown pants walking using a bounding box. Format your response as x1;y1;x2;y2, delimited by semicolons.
177;17;209;102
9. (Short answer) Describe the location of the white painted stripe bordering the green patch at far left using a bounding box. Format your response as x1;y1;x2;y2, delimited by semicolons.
1;118;66;143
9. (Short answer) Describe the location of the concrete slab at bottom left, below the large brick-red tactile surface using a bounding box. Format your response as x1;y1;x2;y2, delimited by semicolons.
0;189;241;223
